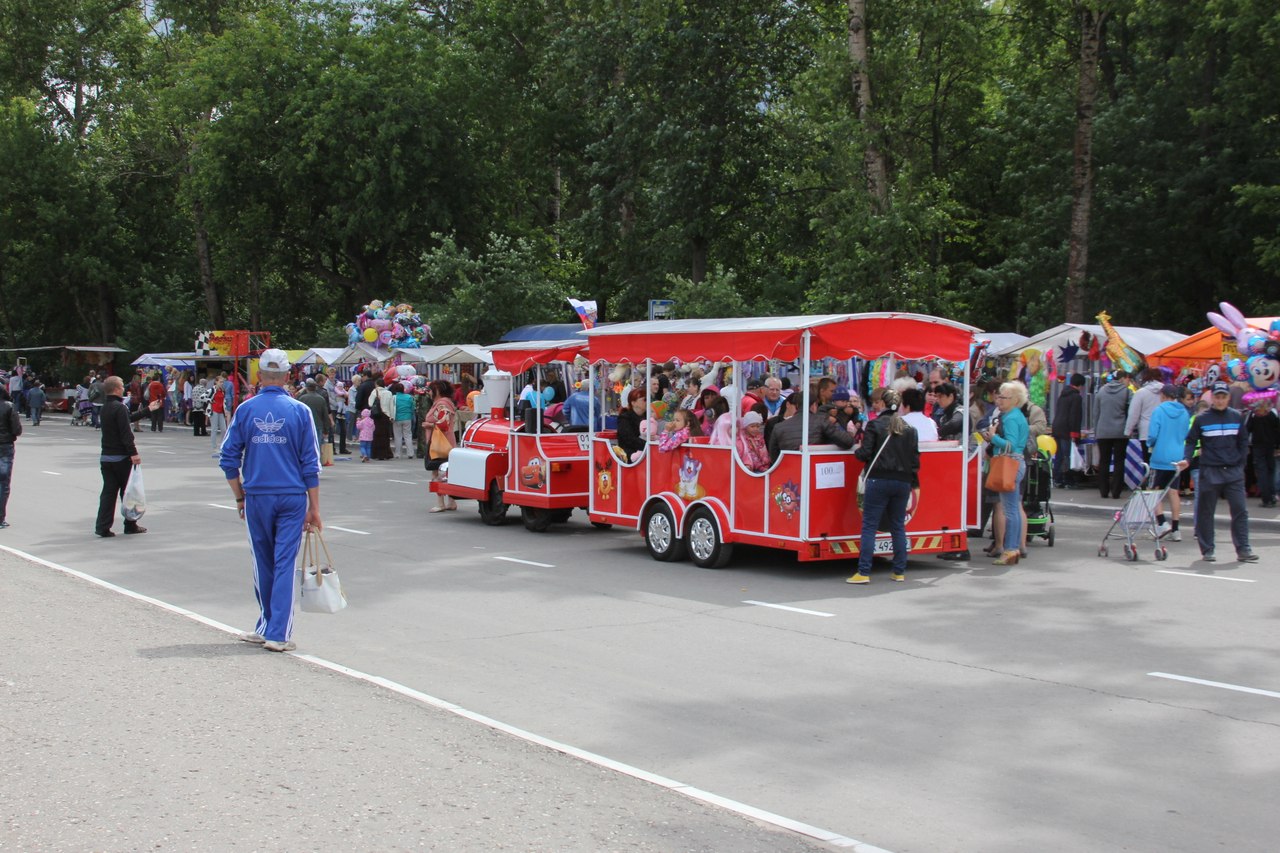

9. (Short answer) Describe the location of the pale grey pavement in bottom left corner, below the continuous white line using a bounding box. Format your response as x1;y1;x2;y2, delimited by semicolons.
0;552;831;853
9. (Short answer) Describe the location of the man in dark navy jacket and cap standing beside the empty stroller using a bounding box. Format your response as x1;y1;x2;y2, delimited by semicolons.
1178;382;1258;562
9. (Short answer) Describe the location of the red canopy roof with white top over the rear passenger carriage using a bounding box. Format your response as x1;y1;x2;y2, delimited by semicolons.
581;313;980;362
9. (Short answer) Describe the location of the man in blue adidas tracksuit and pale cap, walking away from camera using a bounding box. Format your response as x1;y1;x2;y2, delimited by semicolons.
219;350;323;652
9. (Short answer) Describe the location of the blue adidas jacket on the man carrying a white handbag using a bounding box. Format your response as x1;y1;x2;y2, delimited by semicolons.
219;386;320;494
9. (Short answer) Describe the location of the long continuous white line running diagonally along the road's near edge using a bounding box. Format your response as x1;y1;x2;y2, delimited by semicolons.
0;546;890;853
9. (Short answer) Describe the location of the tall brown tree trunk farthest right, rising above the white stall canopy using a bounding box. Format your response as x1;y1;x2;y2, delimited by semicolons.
1065;6;1107;323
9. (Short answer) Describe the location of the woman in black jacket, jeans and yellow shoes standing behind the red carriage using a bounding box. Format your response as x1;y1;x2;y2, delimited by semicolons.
847;388;920;584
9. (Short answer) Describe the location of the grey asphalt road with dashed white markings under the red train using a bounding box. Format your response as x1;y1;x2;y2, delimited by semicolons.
0;420;1280;852
